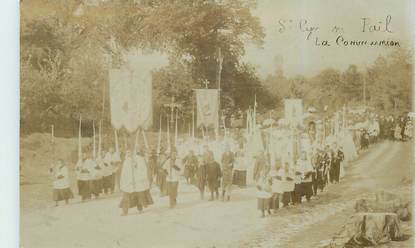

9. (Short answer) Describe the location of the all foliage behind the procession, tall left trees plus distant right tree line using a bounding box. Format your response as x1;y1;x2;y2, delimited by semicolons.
21;0;412;136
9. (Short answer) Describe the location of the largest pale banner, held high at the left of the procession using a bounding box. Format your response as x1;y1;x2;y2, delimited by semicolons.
110;68;153;132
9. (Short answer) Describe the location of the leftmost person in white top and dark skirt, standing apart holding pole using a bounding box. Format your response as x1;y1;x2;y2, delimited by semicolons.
49;159;73;206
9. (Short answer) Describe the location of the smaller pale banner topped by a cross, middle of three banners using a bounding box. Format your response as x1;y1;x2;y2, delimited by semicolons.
196;89;219;128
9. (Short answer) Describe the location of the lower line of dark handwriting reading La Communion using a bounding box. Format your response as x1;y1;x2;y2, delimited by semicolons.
314;35;401;47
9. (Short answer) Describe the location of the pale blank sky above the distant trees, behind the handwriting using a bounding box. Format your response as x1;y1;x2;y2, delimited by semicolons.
244;0;415;78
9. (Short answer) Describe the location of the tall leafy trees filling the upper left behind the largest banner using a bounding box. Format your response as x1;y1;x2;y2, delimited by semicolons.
21;0;270;134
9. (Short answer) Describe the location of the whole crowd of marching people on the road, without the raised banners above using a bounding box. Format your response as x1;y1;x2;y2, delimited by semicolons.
50;110;412;217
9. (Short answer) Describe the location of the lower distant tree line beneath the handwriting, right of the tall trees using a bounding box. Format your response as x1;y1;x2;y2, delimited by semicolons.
264;48;413;115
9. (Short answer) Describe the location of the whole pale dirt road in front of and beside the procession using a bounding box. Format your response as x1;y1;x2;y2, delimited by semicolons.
21;142;413;248
